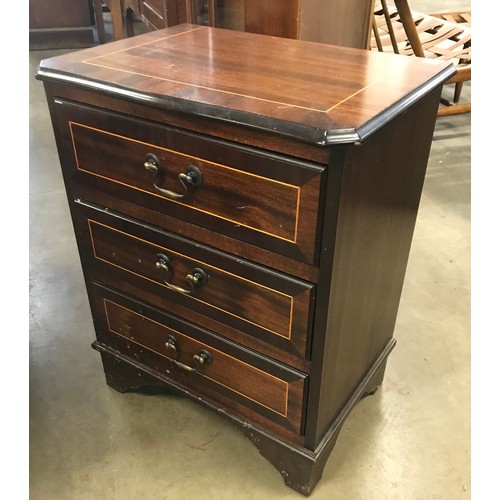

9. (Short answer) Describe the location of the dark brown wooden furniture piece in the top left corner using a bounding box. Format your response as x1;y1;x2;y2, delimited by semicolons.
29;0;95;50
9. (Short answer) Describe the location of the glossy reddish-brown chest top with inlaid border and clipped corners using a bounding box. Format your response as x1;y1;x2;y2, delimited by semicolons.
37;24;455;145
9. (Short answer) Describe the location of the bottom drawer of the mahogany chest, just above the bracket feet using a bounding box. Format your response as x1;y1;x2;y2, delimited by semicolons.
91;284;308;438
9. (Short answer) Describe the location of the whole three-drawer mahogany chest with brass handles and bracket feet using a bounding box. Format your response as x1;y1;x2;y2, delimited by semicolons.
37;25;454;495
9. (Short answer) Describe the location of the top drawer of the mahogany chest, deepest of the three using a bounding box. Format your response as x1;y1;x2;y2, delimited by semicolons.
56;100;325;264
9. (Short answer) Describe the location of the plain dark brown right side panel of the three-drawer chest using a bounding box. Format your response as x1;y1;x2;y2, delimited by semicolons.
306;90;439;448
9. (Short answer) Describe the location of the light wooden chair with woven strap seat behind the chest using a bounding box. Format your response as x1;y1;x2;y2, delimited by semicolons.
371;0;472;116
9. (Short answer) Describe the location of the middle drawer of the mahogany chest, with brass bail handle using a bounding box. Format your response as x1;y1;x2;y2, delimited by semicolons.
79;201;315;357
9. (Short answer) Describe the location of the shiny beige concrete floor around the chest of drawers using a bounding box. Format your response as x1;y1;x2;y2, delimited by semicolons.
29;2;471;500
